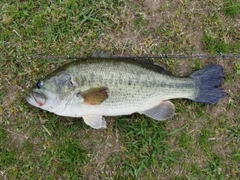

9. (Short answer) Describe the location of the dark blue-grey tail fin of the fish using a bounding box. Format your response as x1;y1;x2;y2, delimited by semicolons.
190;64;226;104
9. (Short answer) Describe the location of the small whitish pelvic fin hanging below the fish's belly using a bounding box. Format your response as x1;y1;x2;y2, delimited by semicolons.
83;115;107;129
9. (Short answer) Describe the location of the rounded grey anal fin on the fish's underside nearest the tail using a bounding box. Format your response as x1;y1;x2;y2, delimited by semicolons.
142;101;175;121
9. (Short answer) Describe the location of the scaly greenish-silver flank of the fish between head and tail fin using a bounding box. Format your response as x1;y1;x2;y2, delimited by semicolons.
67;61;195;109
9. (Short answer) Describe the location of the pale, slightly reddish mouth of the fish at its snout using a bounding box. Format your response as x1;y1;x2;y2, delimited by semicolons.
26;92;46;107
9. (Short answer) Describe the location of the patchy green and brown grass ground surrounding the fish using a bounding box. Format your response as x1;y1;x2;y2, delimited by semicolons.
0;0;240;179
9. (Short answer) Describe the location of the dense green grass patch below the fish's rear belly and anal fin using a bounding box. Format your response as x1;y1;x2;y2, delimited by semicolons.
113;117;178;178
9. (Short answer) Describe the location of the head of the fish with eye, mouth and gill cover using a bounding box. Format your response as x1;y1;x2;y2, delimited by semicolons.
26;71;76;113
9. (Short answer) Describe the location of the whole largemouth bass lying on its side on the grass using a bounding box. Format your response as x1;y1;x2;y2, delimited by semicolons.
26;57;226;129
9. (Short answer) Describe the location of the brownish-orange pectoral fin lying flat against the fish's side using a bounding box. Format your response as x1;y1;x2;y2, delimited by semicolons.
77;87;108;105
